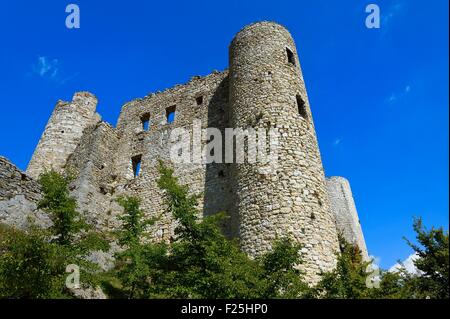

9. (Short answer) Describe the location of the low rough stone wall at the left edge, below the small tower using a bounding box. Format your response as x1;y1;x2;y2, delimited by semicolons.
0;156;50;229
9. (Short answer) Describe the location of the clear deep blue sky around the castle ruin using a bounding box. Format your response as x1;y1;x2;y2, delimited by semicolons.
0;0;449;267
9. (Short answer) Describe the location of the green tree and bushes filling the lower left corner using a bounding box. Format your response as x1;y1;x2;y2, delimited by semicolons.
0;171;109;298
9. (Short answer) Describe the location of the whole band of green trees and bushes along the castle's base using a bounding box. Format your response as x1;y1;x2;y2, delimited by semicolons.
0;168;449;299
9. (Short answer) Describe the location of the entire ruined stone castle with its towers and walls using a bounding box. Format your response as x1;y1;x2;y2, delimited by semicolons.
0;22;368;283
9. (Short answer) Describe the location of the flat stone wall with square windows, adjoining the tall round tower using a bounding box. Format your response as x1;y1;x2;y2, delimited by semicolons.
115;72;231;239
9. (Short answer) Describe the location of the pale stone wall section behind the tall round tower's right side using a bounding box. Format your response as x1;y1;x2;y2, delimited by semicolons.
327;176;369;260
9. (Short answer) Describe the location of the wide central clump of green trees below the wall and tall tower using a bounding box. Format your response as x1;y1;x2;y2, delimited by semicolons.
110;163;307;298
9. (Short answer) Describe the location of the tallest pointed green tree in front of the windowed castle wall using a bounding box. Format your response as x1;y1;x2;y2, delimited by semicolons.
150;163;261;298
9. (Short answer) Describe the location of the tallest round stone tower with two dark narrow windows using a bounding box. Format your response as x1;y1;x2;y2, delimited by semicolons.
229;22;338;284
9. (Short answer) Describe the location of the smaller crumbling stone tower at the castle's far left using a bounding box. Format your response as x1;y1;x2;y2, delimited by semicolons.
27;92;100;178
